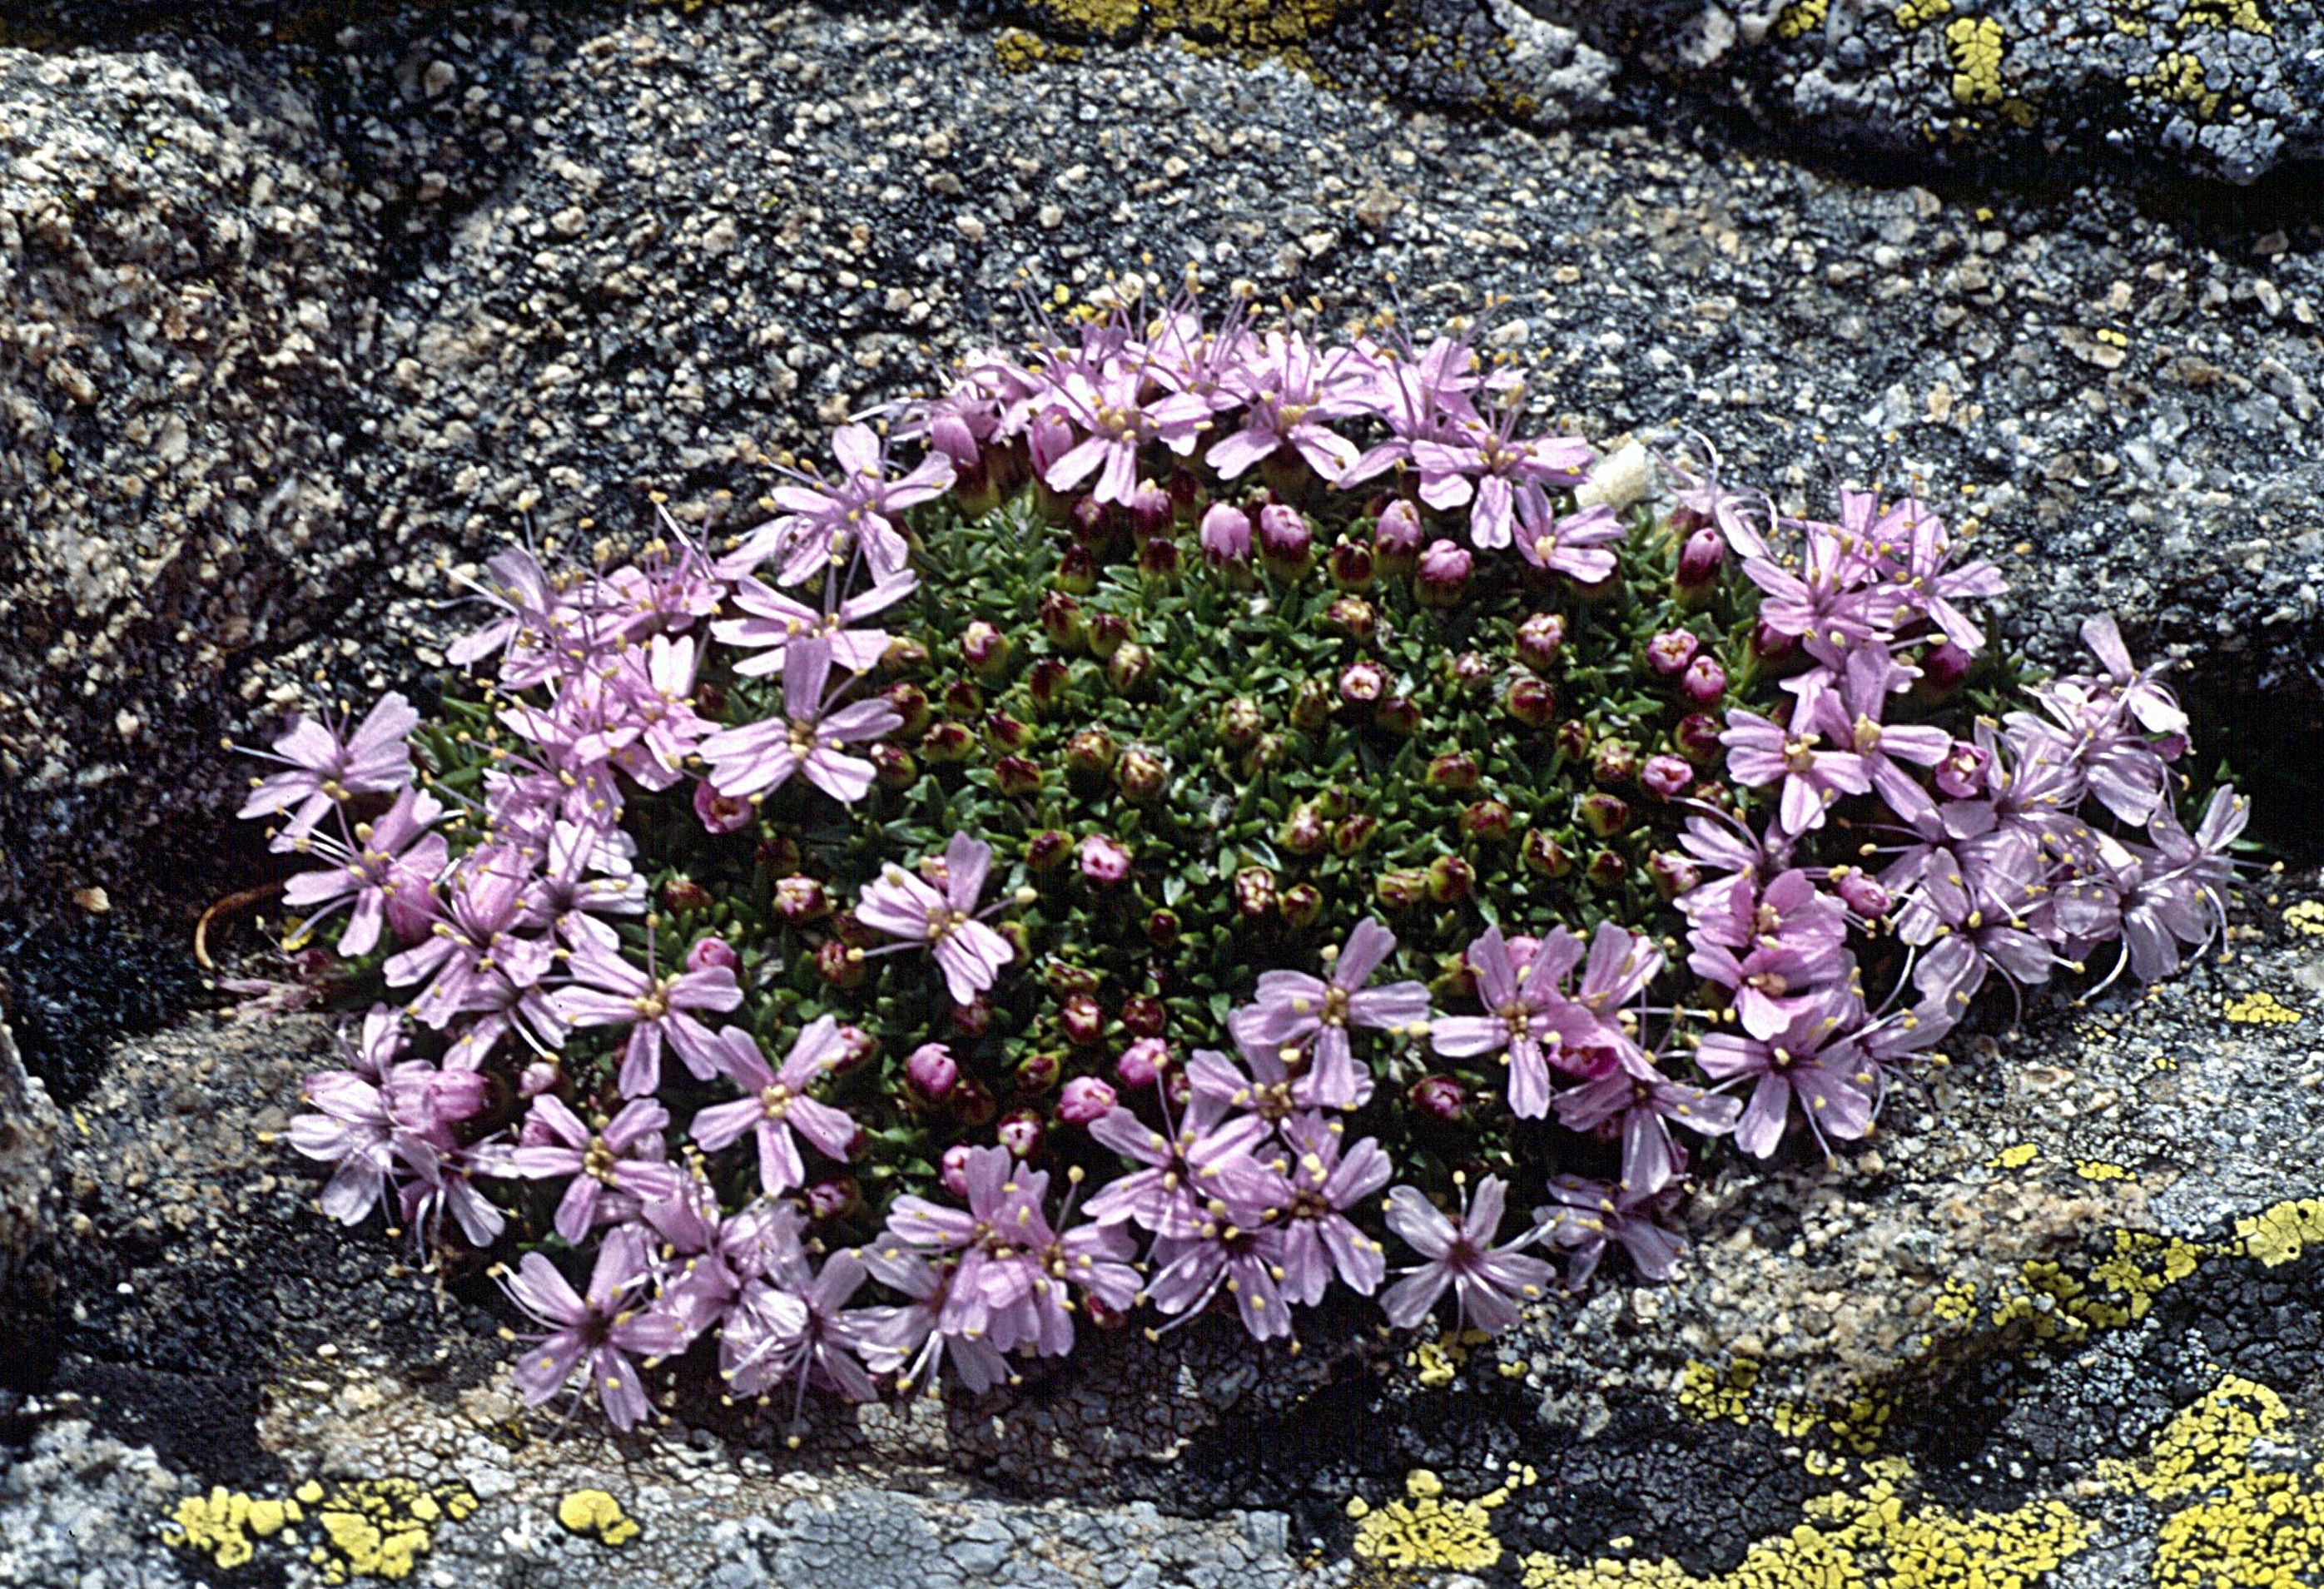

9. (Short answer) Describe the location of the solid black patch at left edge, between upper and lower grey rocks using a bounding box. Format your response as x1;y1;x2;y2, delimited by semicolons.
0;916;202;1104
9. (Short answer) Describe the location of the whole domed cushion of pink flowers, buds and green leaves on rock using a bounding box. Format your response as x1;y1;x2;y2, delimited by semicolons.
244;291;2242;1427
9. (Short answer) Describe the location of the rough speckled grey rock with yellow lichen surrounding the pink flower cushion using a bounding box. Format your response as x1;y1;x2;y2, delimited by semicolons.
0;0;2324;1589
